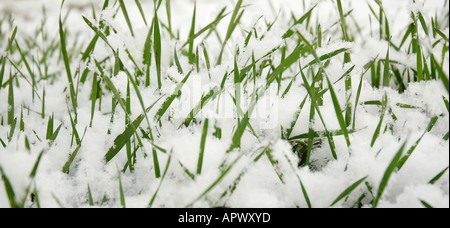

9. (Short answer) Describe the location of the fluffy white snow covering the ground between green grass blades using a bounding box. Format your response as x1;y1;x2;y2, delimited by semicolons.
0;0;449;208
